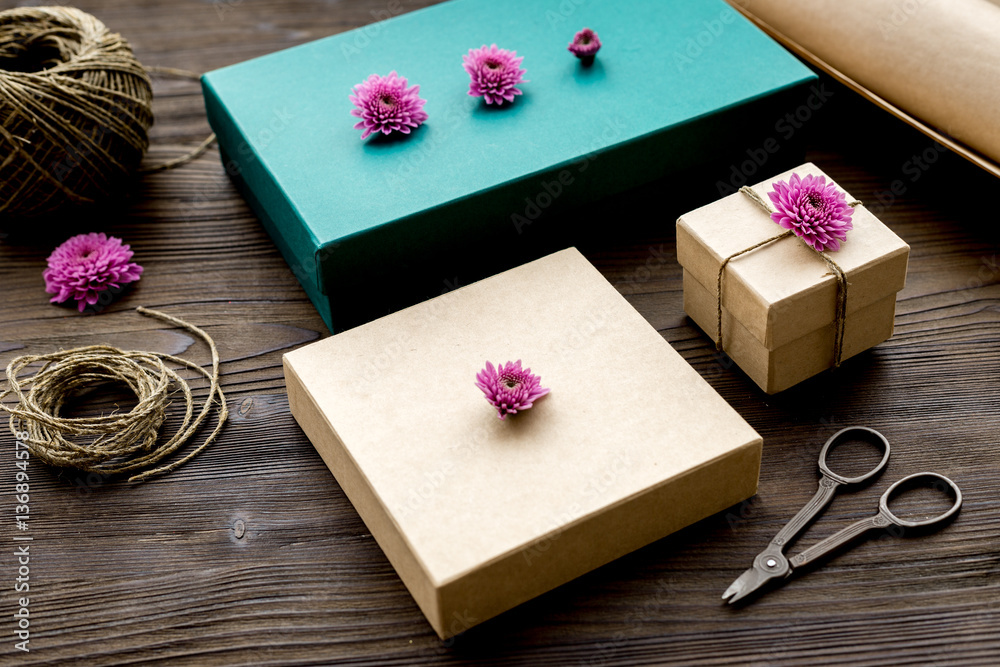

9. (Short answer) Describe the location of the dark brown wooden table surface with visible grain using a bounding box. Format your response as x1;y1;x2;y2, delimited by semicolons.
0;0;1000;665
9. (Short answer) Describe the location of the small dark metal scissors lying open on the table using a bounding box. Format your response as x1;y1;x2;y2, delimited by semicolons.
722;426;962;604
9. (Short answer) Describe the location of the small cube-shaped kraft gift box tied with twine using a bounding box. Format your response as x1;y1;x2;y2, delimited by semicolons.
677;163;910;394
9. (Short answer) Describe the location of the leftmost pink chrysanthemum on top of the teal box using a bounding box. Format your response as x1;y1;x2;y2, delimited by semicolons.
350;70;427;139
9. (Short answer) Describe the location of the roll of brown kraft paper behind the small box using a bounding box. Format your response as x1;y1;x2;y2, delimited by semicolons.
730;0;1000;173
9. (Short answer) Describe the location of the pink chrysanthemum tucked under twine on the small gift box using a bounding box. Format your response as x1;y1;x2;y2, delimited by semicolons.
767;174;854;252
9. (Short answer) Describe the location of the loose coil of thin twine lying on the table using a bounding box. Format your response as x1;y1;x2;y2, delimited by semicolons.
0;307;229;482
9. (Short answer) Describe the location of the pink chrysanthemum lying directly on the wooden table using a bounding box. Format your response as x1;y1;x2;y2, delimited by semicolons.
42;233;142;313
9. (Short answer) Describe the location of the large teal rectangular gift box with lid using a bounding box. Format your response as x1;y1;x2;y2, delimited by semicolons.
202;0;815;331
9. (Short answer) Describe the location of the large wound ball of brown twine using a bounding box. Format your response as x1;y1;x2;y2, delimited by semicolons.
0;7;153;217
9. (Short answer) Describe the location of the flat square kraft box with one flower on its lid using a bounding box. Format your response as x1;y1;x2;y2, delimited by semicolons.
284;249;761;638
